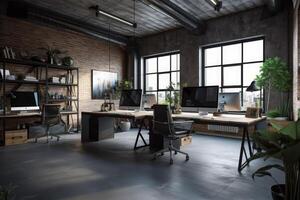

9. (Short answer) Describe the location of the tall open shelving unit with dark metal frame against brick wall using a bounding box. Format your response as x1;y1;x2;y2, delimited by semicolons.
0;58;80;146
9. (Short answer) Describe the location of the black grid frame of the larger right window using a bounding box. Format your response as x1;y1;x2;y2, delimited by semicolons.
201;36;266;112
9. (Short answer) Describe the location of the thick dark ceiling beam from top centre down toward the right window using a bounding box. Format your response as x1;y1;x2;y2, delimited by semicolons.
140;0;205;34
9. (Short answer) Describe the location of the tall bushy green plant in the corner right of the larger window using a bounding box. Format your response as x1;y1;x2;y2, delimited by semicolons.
256;57;292;118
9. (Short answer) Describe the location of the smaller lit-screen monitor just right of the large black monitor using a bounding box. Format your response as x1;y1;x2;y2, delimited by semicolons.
219;92;241;111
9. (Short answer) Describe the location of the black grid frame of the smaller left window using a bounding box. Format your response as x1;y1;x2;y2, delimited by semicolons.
143;51;181;102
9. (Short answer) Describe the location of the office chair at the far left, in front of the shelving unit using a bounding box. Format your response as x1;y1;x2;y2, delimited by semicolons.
35;104;65;143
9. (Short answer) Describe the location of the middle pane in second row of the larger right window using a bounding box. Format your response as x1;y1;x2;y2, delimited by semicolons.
223;66;241;86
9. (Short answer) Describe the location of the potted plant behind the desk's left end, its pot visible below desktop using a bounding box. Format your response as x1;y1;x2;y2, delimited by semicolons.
113;79;133;132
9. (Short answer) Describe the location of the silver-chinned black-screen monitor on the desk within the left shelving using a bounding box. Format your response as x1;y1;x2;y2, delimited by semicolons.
10;92;40;111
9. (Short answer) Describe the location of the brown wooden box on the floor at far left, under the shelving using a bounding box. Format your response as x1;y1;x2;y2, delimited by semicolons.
5;129;27;145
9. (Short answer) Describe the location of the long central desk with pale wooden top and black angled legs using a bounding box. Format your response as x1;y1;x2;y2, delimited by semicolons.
82;110;266;171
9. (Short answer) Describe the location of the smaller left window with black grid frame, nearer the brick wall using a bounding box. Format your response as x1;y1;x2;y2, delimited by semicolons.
144;53;180;103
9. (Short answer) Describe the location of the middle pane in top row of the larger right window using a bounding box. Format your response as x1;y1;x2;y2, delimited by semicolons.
223;44;242;65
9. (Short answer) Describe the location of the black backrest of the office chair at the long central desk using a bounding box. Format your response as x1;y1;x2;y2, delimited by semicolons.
152;104;174;136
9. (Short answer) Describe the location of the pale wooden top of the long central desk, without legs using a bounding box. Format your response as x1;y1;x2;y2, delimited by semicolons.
83;110;267;125
